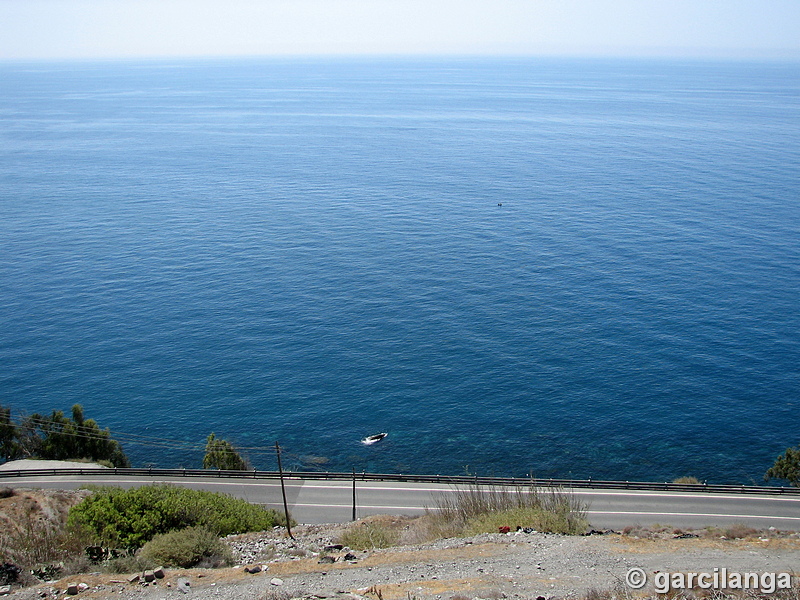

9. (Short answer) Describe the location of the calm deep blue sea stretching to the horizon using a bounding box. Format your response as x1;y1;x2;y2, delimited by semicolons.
0;58;800;483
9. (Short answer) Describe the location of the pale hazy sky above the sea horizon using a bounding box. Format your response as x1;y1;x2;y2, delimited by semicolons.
0;0;800;60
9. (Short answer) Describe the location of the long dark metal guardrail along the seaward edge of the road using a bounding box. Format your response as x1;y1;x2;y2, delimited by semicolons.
0;468;800;496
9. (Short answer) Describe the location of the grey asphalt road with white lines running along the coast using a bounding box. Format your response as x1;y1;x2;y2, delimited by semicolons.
6;470;800;531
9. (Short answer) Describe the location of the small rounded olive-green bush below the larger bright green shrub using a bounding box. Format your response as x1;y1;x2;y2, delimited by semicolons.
139;527;234;568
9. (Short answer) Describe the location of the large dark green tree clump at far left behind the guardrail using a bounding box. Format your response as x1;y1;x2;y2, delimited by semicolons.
7;404;130;467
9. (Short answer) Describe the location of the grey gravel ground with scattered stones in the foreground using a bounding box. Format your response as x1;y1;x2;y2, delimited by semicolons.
7;525;800;600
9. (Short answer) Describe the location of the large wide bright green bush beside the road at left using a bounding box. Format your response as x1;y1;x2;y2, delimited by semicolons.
68;484;281;548
